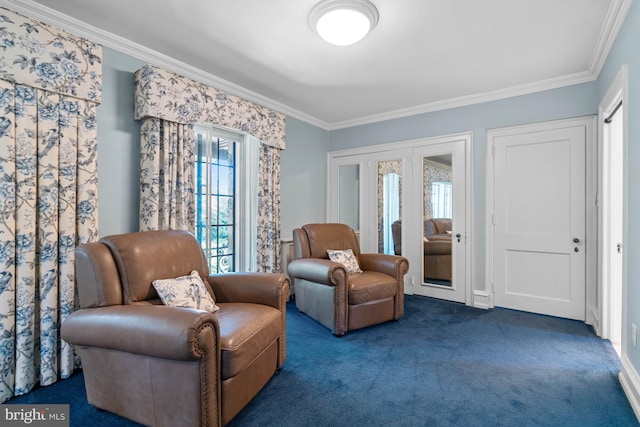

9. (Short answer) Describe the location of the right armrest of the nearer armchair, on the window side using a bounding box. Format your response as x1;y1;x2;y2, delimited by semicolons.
207;273;289;310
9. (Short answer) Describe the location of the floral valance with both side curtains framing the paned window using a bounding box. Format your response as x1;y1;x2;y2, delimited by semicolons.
135;65;285;271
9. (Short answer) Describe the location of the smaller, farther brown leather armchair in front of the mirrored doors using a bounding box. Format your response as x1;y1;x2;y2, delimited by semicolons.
288;224;409;336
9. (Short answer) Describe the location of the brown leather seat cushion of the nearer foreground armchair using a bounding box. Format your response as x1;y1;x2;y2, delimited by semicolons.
216;303;282;380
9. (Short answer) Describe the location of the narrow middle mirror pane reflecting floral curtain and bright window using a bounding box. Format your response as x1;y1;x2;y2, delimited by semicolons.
378;160;402;255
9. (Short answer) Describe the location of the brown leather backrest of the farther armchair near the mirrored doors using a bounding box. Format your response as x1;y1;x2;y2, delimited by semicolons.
294;224;360;259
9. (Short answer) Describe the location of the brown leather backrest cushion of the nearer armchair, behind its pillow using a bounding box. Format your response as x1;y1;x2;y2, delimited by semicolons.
100;230;213;304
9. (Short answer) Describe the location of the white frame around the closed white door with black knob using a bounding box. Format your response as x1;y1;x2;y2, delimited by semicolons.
485;116;598;325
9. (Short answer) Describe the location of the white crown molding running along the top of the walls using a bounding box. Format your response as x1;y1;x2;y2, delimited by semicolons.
0;0;633;131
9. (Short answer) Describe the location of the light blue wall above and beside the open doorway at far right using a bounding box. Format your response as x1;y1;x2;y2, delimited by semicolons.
598;1;640;372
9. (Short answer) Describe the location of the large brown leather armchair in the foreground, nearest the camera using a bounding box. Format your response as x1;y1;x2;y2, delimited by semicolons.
61;231;289;427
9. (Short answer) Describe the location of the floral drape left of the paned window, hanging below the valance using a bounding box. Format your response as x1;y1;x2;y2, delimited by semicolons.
140;117;196;233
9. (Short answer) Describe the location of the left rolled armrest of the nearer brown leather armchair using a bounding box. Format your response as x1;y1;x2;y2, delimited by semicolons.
60;305;220;361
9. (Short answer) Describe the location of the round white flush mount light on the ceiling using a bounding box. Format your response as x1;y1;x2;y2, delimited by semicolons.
309;0;378;46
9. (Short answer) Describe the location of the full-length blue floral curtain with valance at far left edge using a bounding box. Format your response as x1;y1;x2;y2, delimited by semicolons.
0;8;102;402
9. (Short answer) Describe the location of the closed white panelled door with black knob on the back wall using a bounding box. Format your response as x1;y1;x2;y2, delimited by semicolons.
488;125;586;320
